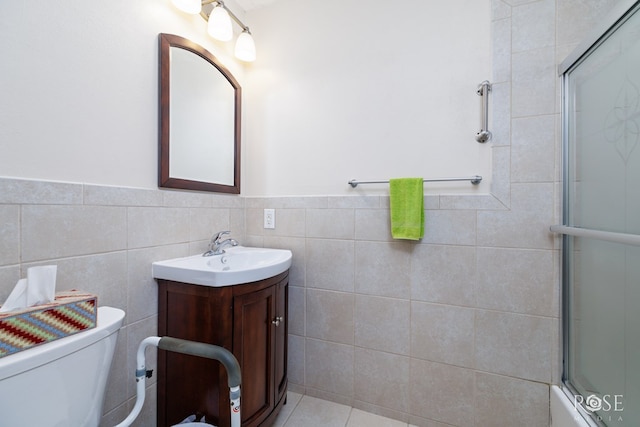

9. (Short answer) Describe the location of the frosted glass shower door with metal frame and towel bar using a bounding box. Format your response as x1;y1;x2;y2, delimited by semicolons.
563;2;640;426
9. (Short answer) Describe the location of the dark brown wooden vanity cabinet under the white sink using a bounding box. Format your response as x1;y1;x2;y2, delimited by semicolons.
157;271;289;427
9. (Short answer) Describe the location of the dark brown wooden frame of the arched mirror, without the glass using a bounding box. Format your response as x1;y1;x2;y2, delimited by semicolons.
158;34;242;194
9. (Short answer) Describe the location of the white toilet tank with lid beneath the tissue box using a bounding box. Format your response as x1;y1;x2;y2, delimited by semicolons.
0;307;124;427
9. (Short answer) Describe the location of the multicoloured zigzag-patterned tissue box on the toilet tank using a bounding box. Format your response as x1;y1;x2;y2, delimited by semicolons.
0;290;98;357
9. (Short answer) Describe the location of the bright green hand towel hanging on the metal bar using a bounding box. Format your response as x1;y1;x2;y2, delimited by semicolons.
389;178;424;240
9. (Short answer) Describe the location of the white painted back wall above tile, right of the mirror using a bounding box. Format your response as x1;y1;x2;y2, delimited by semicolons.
243;0;491;195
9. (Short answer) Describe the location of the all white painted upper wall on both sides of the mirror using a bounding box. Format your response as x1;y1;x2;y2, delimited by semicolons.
0;0;491;196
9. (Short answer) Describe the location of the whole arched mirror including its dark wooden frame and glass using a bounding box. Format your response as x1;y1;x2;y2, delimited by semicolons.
158;34;242;194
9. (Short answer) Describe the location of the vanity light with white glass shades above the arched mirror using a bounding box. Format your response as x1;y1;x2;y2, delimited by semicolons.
171;0;256;62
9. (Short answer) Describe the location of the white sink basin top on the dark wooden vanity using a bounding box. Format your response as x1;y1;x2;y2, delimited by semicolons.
151;246;291;286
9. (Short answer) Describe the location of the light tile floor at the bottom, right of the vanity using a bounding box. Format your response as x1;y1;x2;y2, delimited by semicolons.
273;392;412;427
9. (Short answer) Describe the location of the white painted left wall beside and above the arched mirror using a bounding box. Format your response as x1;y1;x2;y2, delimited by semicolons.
0;0;243;188
